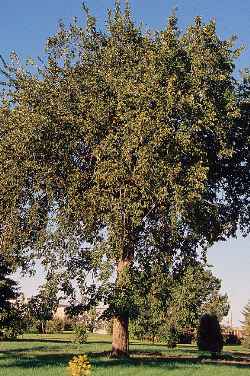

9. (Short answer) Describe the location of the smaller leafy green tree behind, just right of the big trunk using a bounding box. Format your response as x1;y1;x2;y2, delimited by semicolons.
131;262;229;341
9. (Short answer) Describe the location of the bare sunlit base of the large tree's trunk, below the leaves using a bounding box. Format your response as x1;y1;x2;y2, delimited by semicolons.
112;315;129;356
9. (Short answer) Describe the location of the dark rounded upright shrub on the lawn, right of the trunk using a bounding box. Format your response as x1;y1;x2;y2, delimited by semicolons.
197;314;223;356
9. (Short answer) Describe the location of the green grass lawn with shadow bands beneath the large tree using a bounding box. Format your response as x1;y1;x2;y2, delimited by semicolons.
0;334;250;376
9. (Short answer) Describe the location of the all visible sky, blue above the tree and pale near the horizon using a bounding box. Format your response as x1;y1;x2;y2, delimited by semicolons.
4;0;250;325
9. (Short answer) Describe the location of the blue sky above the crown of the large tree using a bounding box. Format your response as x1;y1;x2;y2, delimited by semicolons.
0;0;250;72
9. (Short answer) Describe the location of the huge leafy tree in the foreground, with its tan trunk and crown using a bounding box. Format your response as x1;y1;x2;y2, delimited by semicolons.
0;1;249;355
